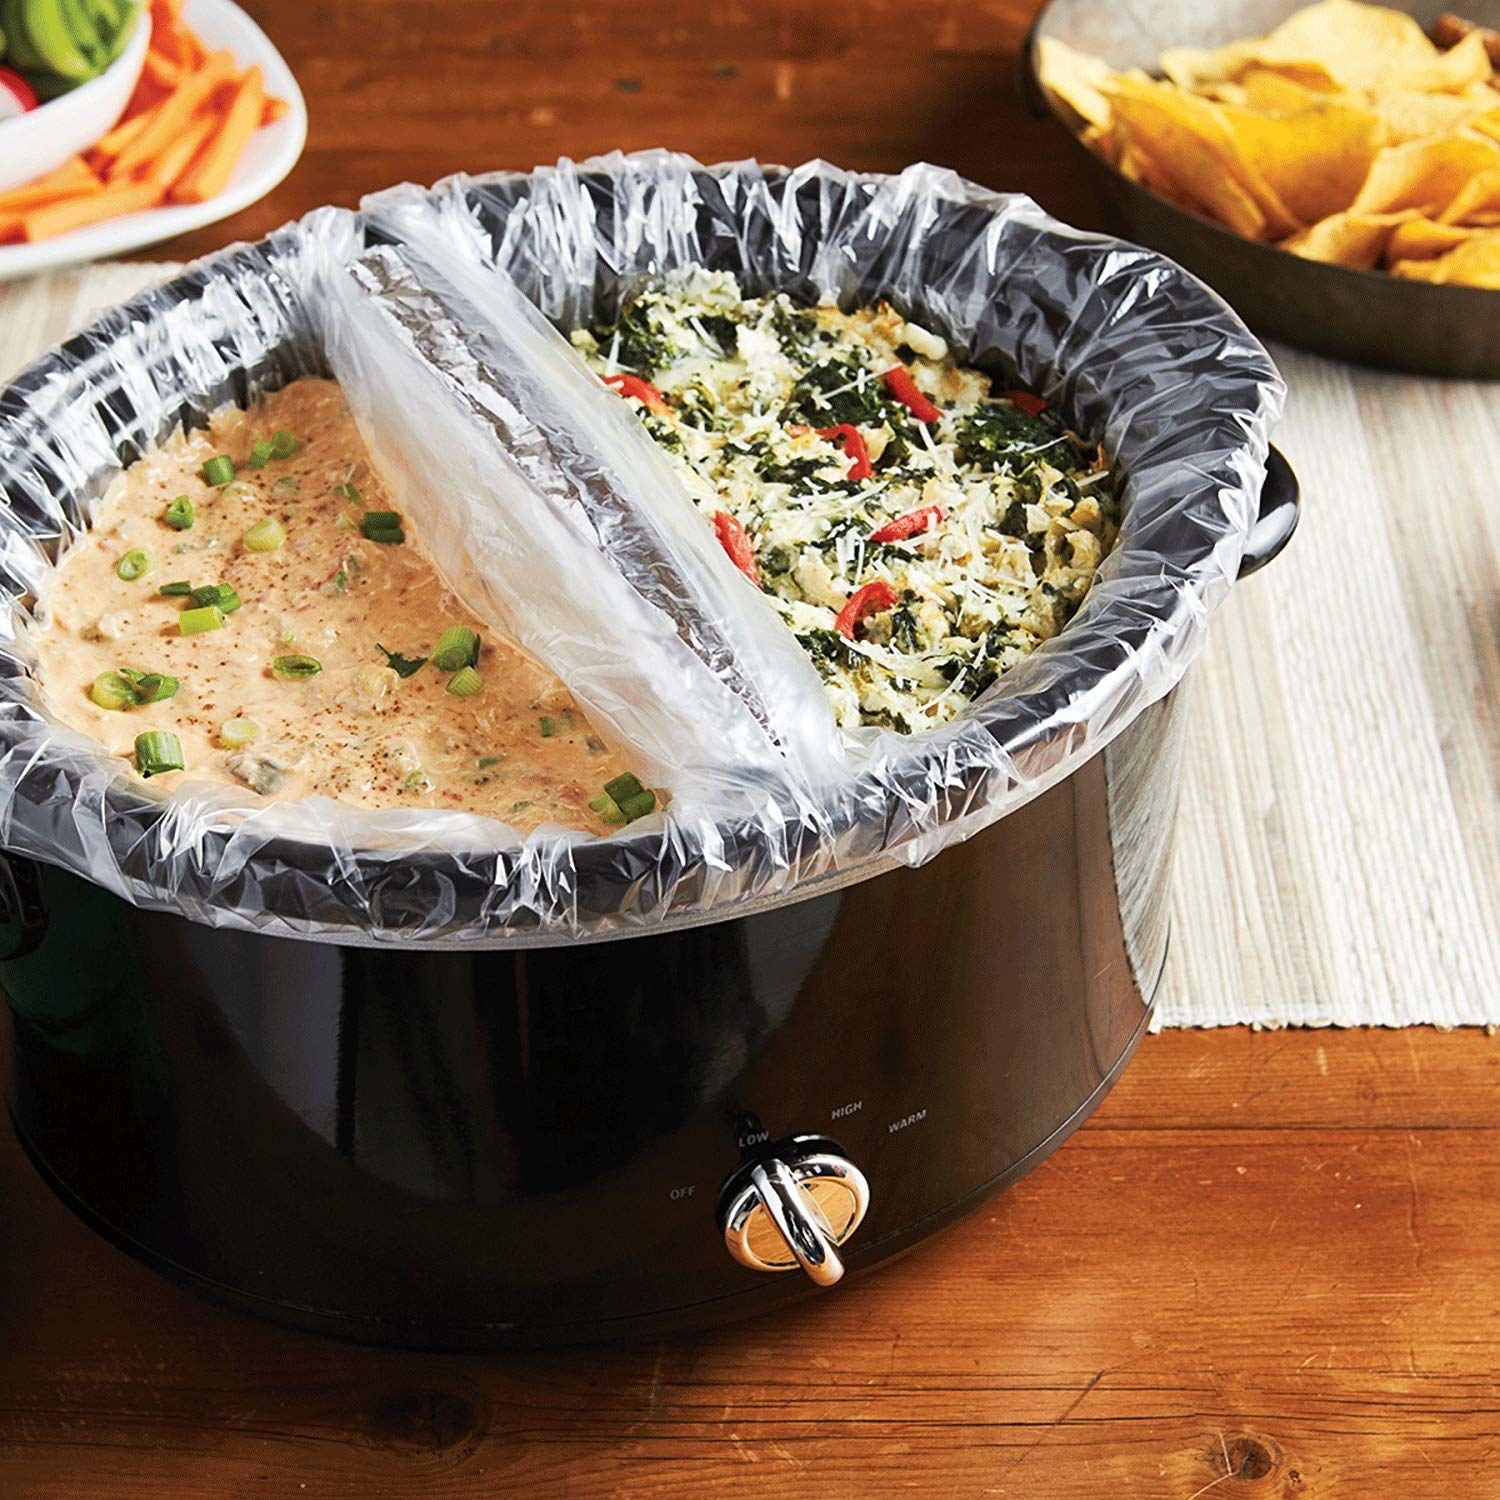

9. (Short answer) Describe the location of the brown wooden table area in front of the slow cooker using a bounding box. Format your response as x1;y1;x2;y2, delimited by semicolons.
0;1029;1500;1500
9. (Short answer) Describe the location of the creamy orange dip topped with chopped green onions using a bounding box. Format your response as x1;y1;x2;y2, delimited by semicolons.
33;380;656;833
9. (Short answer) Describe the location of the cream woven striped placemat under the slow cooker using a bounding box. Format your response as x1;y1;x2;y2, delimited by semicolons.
0;264;1500;1026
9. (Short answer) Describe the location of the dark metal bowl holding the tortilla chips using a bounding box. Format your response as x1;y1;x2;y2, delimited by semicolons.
1023;0;1500;380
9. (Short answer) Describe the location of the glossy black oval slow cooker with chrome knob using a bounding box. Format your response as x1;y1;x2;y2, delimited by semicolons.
0;159;1298;1347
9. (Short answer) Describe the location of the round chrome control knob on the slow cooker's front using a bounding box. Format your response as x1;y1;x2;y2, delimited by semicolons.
720;1137;870;1287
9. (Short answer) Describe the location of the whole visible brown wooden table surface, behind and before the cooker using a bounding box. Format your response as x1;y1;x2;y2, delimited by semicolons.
0;0;1500;1500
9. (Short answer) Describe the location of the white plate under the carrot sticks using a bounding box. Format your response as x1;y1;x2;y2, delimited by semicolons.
0;0;308;281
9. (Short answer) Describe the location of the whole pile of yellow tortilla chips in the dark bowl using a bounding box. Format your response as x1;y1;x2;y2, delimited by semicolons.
1038;0;1500;285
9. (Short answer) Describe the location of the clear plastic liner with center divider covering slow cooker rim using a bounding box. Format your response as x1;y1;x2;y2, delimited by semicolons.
0;153;1283;944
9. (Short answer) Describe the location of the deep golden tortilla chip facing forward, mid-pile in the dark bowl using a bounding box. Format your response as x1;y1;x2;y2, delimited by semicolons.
1223;104;1380;224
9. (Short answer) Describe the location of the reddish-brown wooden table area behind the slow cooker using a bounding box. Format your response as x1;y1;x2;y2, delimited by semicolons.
167;0;1098;260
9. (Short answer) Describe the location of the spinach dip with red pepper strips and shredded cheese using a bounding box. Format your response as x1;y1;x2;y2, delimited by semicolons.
570;270;1118;732
